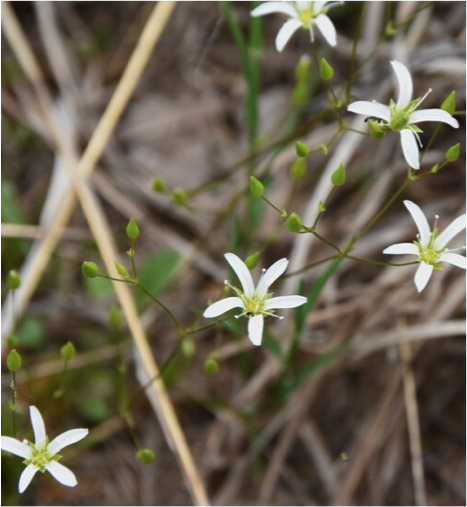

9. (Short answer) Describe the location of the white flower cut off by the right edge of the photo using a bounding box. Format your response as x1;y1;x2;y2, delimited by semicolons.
383;201;467;292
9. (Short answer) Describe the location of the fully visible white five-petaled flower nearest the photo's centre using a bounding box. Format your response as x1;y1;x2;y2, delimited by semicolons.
203;253;307;345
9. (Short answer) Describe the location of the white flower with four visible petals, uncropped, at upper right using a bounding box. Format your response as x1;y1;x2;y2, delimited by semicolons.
347;61;459;169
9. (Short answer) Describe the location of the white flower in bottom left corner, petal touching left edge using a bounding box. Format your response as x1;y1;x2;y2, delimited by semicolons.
2;407;88;493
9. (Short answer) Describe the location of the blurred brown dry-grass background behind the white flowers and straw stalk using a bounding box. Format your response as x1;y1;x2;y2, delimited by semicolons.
1;0;467;507
